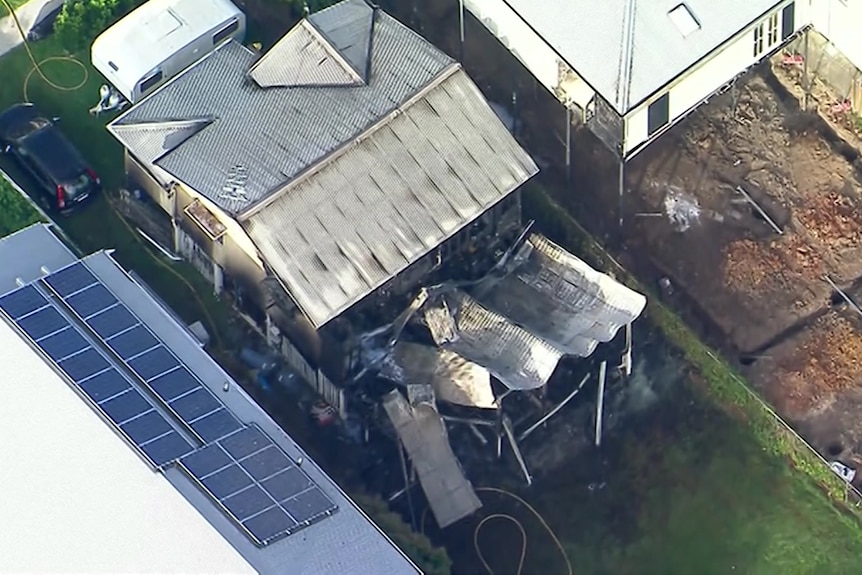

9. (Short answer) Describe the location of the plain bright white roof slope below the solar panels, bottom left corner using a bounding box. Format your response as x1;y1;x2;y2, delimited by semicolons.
0;321;255;573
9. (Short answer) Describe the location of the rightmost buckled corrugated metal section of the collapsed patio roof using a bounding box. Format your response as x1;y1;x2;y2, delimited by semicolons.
471;234;646;357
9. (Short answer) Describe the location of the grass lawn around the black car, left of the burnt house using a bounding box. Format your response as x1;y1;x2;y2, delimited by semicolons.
0;38;233;346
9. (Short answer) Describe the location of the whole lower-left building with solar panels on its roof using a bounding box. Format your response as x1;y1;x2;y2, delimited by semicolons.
0;224;419;575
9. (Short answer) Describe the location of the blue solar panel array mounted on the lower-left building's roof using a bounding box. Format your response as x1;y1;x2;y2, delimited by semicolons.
0;262;337;545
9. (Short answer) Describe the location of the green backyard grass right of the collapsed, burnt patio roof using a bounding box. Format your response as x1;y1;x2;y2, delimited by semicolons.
510;187;862;575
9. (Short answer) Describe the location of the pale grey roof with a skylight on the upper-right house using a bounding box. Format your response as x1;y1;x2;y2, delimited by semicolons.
500;0;784;114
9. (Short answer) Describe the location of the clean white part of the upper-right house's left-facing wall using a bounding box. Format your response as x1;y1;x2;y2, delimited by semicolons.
464;0;572;93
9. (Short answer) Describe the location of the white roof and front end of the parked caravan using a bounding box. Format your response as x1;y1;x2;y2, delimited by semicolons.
91;0;242;95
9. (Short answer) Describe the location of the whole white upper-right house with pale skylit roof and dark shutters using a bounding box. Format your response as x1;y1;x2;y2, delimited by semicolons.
463;0;862;160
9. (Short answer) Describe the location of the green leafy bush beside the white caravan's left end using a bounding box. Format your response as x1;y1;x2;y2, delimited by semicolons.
54;0;143;52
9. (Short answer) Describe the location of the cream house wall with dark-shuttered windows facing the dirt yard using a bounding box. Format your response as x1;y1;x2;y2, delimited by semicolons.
623;0;808;158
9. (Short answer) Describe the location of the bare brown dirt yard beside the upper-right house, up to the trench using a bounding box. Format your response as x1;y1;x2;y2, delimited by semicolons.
625;75;862;352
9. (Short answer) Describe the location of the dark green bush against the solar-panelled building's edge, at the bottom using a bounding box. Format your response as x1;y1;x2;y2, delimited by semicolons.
351;494;452;575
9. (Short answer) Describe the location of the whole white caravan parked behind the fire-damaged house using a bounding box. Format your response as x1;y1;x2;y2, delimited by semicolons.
90;0;245;104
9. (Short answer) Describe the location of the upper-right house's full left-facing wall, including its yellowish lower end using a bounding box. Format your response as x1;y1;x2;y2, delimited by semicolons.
464;0;594;108
